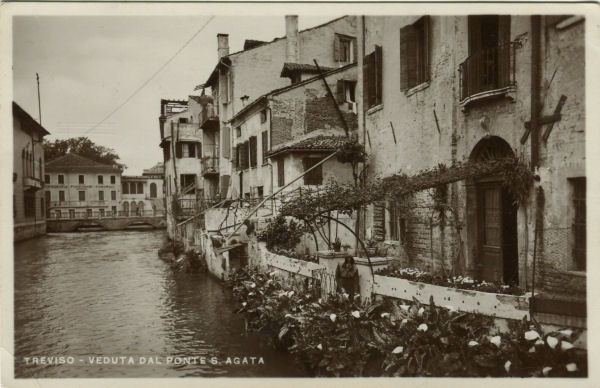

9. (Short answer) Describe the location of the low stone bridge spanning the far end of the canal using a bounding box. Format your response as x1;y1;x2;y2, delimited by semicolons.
46;215;167;233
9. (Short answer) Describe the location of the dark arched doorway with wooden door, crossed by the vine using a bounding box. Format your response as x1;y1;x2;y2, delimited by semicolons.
467;136;519;284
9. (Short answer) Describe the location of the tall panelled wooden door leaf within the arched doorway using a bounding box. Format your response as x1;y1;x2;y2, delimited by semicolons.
478;183;503;282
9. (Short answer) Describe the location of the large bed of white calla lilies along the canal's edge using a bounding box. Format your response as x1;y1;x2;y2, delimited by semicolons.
230;268;587;377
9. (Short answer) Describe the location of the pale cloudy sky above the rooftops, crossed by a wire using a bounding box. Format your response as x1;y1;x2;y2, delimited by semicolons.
13;15;341;175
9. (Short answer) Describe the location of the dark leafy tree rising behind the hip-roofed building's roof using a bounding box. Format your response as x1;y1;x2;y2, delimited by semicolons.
44;137;127;169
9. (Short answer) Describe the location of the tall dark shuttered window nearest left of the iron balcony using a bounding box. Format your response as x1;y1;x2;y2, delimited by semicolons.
400;16;429;90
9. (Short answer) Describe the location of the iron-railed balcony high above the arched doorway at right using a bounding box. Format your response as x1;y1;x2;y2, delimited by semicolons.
458;42;520;110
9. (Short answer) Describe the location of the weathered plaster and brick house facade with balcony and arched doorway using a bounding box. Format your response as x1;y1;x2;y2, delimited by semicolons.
358;15;586;310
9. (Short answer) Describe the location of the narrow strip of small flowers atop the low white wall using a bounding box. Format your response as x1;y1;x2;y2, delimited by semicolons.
376;267;523;295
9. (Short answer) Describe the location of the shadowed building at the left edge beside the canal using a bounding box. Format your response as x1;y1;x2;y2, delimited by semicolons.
12;102;49;241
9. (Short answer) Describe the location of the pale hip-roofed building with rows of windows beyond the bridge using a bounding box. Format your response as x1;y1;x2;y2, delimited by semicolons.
44;153;121;218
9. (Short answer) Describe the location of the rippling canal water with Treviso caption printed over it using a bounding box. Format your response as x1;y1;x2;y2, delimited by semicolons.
14;231;302;378
